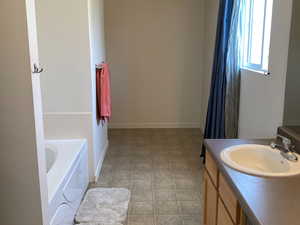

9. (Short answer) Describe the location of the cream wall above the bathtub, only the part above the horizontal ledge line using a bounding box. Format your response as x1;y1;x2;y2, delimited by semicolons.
37;0;92;113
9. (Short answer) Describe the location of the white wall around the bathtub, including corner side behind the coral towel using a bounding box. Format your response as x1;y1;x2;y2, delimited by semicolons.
38;0;107;181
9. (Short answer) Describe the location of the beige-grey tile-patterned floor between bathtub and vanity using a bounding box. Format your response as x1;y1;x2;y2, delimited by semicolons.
92;129;202;225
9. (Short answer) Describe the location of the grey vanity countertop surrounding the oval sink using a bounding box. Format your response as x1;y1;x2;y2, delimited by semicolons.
205;139;300;225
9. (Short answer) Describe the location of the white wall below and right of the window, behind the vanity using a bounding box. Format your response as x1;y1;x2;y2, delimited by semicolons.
239;0;293;138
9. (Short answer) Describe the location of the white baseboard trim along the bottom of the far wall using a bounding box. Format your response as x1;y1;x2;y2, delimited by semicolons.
109;121;201;128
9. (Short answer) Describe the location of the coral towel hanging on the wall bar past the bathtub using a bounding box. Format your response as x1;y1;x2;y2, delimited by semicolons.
96;63;111;122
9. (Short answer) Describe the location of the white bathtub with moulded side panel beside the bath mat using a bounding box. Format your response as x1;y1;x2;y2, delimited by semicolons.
46;139;89;225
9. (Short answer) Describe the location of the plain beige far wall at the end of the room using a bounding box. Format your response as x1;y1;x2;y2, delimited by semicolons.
105;0;204;127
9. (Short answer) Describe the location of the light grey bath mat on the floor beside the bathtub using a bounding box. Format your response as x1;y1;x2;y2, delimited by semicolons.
75;188;130;225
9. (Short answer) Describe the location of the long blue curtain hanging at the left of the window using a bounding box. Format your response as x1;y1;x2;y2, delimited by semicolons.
201;0;244;156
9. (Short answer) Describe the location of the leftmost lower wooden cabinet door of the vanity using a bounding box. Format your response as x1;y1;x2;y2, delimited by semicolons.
203;171;218;225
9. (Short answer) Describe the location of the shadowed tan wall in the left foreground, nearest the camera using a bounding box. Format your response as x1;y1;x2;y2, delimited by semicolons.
0;0;43;225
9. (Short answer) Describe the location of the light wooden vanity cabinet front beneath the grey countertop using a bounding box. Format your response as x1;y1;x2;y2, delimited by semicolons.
203;152;246;225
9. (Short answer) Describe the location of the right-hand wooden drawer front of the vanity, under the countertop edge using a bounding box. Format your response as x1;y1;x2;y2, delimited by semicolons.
219;173;240;224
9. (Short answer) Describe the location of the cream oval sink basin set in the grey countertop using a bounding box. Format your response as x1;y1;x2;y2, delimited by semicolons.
221;144;300;177
